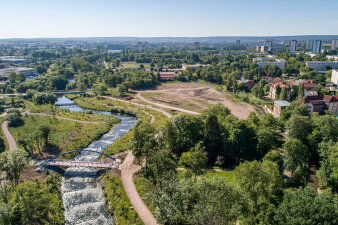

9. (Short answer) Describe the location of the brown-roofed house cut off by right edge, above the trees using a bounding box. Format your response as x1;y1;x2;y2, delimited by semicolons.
300;95;338;116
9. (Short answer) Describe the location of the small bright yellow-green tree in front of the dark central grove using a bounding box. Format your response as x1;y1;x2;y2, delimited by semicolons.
180;143;208;176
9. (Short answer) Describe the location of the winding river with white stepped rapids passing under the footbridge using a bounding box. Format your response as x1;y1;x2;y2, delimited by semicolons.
56;96;136;225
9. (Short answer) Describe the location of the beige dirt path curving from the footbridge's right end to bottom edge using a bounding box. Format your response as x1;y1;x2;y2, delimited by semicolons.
120;150;157;225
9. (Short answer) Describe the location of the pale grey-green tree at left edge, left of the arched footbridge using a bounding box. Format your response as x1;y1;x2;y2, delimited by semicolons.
0;149;28;186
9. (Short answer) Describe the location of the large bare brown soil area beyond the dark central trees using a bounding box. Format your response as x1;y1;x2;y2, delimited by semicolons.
139;83;255;119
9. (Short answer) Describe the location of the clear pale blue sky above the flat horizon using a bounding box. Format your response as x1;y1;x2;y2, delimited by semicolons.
0;0;338;38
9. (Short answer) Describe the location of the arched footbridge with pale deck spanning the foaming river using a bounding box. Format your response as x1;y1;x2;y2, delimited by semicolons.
36;149;119;172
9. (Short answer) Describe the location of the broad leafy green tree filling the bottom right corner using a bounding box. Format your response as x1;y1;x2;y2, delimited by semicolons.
275;187;338;225
